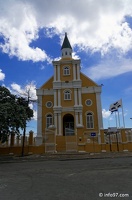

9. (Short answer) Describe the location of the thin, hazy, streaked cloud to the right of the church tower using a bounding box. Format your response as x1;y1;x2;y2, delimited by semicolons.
83;58;132;80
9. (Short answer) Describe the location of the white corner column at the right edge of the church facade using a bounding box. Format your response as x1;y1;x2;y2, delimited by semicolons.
96;93;103;129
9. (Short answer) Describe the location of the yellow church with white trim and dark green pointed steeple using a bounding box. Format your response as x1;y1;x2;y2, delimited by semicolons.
36;33;103;152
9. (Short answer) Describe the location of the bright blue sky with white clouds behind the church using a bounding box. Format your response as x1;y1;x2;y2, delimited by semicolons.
0;0;132;133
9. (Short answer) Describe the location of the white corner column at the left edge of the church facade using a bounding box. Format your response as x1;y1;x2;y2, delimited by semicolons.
37;95;42;137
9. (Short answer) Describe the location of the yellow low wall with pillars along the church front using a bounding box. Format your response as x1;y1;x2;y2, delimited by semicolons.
0;130;132;156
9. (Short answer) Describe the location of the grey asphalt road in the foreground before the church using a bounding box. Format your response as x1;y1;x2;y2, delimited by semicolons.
0;157;132;200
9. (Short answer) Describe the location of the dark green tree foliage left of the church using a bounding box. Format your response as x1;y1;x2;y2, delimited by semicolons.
0;86;33;142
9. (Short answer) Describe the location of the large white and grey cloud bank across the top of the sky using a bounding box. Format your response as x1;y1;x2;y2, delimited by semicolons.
0;0;132;62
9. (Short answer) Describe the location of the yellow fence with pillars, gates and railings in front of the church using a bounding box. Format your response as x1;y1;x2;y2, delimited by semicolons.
0;129;132;155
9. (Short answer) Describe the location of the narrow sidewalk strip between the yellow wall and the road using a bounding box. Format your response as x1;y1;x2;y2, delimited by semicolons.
0;152;132;164
